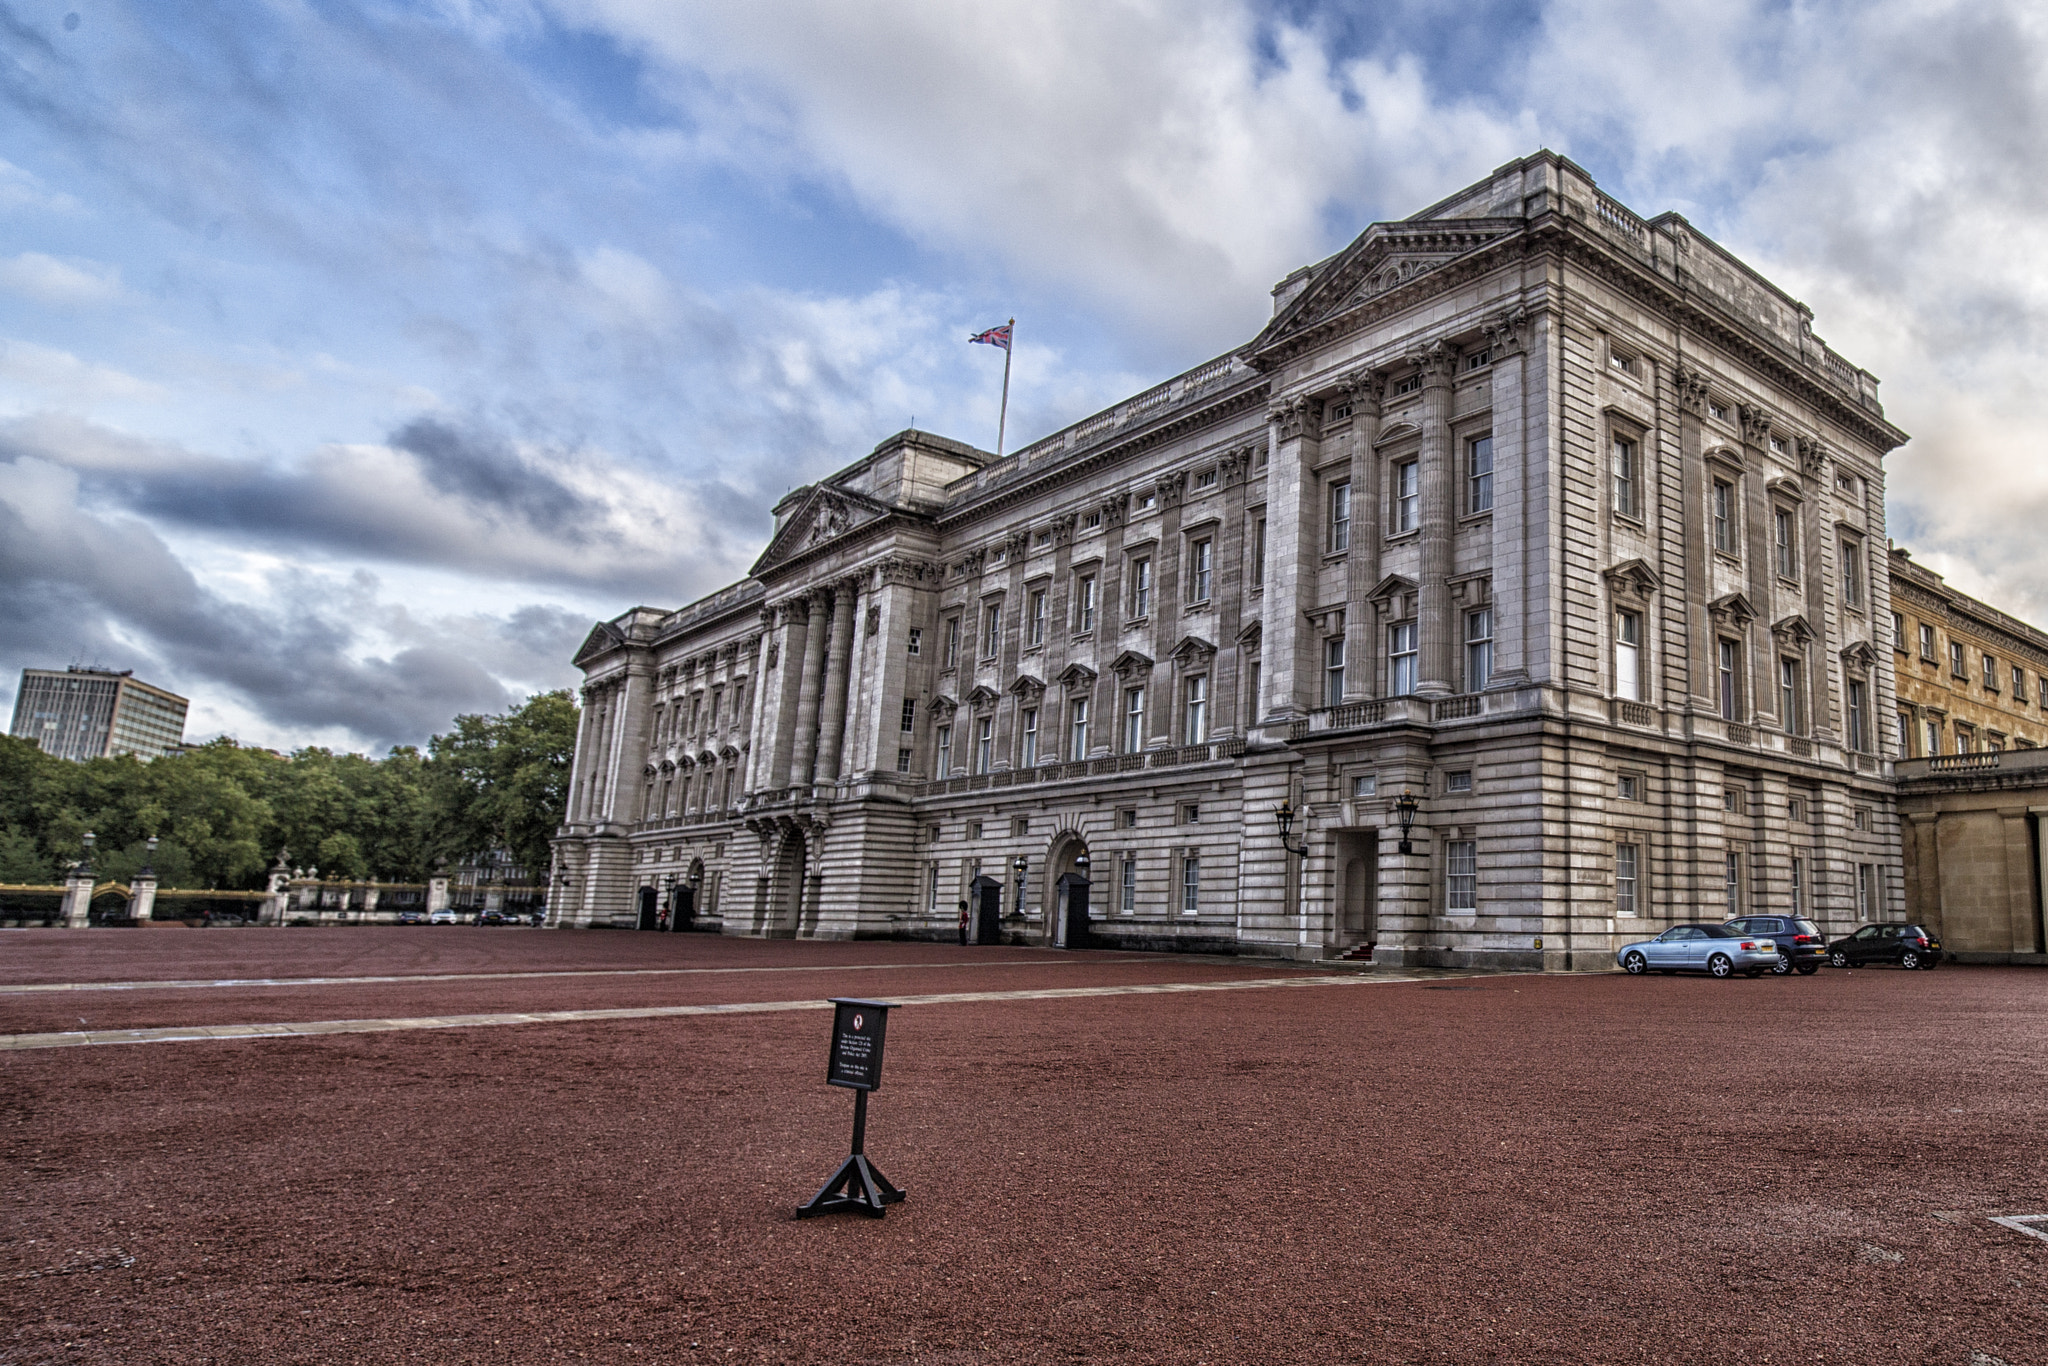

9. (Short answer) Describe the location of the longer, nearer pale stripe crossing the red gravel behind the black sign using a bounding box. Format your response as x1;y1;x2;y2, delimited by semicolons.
0;973;1423;1053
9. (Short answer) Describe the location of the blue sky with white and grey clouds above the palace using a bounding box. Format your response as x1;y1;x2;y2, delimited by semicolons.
0;0;2048;752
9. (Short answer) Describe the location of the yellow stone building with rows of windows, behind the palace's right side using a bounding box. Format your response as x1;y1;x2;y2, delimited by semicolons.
1890;547;2048;760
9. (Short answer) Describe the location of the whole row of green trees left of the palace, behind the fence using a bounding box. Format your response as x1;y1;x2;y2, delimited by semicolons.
0;692;575;887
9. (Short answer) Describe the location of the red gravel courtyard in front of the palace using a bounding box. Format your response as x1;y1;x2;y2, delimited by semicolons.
0;928;2048;1366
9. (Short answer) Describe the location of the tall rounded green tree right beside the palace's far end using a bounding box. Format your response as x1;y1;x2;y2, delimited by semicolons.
428;690;575;874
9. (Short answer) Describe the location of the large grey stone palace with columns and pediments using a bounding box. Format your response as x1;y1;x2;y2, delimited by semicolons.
551;152;1905;969
